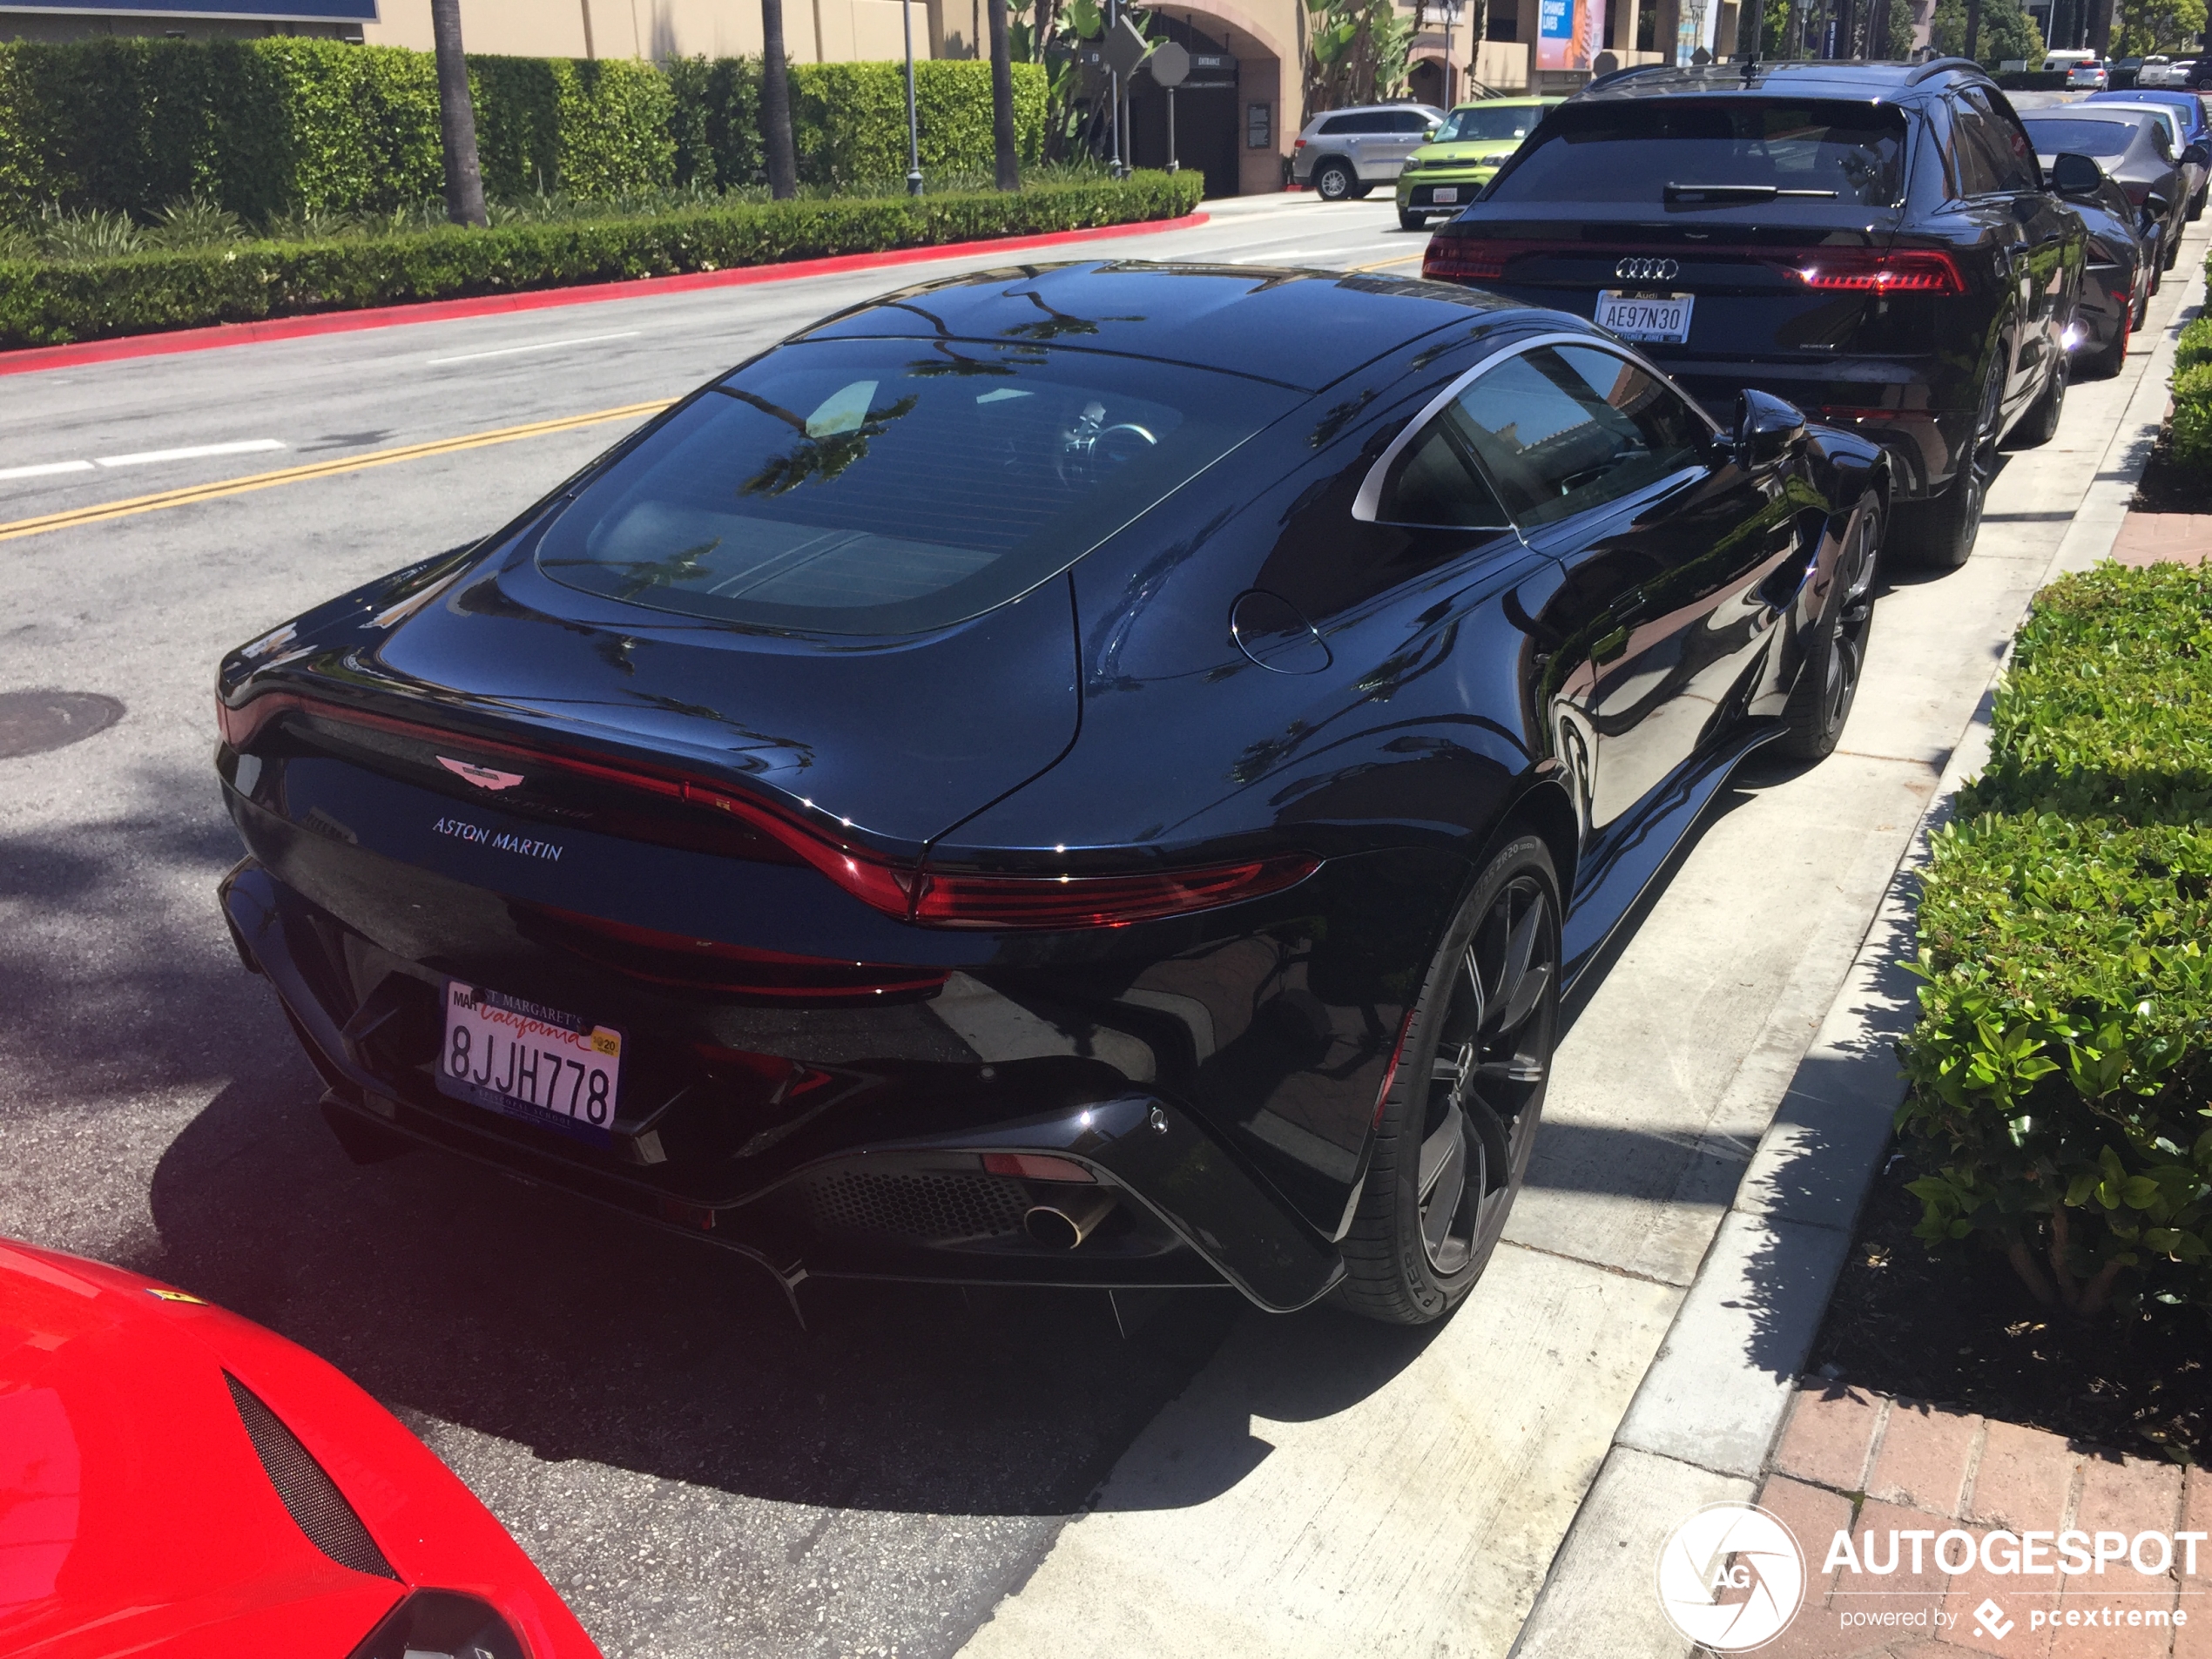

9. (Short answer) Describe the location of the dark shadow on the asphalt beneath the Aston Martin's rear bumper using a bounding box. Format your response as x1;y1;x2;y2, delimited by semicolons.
131;1066;1291;1515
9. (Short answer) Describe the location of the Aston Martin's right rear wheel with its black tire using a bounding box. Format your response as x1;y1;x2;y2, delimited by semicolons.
1339;836;1560;1325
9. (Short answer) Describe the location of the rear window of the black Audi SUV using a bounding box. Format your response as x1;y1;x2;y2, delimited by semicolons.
1484;98;1905;208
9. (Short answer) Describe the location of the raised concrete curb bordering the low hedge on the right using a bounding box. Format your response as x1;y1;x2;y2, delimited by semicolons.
1508;250;2205;1659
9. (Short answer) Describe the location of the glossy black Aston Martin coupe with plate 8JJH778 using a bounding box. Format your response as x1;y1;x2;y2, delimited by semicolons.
217;263;1889;1323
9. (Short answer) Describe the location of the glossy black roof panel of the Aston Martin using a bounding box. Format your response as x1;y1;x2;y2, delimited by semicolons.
799;261;1524;392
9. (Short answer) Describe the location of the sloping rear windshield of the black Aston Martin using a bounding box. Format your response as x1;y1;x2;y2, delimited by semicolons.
537;341;1301;635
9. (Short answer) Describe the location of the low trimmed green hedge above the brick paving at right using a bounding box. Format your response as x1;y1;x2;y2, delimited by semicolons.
1898;564;2212;1314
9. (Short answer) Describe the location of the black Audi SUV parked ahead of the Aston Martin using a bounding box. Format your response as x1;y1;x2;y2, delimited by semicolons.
1425;57;2088;566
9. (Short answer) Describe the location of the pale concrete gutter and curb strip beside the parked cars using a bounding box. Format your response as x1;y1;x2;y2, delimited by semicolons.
962;237;2203;1659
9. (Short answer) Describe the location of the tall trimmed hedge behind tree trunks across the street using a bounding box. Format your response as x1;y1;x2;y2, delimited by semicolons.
0;37;1044;221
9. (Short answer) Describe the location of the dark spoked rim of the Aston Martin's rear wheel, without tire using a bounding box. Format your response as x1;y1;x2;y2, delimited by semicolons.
1418;876;1560;1278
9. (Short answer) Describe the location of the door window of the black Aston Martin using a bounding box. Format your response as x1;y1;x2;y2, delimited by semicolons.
1455;345;1708;527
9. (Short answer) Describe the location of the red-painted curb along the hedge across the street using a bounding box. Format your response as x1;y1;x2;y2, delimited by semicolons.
0;212;1210;374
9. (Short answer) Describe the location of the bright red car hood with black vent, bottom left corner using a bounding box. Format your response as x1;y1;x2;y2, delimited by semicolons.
0;1243;595;1659
